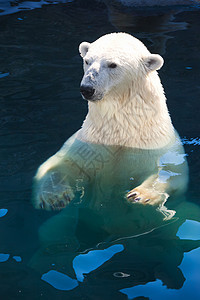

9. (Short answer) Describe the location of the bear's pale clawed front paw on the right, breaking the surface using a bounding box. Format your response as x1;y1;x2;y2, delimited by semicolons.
126;186;169;205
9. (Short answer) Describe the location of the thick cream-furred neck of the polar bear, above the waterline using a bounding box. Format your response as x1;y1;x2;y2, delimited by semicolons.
78;77;175;149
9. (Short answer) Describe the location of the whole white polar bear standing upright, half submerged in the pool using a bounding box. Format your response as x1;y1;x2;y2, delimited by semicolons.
33;33;188;225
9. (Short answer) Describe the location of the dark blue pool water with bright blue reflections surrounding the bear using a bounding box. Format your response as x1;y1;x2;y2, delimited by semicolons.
0;1;200;300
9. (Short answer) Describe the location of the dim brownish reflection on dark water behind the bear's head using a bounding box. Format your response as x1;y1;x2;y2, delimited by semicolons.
108;2;188;55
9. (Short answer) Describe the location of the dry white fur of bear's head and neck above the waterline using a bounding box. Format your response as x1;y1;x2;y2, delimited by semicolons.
78;33;175;149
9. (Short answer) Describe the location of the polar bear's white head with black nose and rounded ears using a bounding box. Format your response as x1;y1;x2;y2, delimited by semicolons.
79;33;163;101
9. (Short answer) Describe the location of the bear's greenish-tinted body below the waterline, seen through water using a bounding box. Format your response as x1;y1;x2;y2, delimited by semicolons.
34;133;188;240
